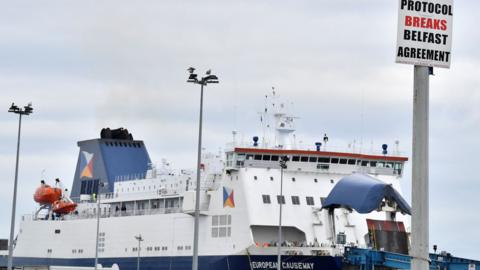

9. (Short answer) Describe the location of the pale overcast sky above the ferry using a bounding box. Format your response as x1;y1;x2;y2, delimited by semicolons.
0;0;480;259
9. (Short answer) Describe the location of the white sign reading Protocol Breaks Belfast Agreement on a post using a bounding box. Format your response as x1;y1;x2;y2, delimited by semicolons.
396;0;453;68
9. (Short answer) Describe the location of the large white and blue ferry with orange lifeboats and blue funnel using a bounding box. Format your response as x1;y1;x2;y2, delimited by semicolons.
0;99;410;270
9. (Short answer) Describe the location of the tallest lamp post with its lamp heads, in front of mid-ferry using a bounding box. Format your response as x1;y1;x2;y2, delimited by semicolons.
187;67;218;270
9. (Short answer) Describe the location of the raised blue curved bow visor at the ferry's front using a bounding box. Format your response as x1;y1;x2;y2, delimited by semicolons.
322;174;411;215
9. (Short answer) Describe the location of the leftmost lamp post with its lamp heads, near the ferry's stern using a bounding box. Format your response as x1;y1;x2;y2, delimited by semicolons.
7;103;33;270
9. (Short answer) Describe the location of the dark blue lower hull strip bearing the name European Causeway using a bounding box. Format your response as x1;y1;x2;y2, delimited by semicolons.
0;255;342;270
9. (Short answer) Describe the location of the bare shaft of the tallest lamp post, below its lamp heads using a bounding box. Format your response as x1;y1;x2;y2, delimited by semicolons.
192;83;204;270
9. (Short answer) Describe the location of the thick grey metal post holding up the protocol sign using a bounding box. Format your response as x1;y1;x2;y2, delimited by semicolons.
411;66;429;270
